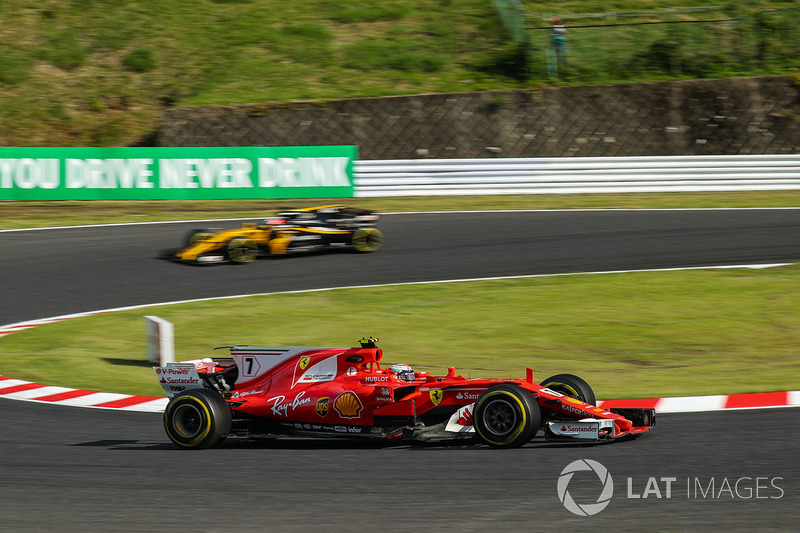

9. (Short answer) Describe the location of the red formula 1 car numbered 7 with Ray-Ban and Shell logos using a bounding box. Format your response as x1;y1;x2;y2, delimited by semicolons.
155;339;655;448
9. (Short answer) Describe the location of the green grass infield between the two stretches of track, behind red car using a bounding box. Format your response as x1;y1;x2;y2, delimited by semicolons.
0;265;800;399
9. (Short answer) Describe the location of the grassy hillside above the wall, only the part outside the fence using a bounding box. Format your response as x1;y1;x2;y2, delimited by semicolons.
0;0;793;146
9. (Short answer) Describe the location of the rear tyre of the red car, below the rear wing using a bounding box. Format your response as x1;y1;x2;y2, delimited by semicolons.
164;389;233;450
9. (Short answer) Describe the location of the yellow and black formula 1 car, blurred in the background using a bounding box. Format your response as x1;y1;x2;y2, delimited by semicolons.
165;205;383;264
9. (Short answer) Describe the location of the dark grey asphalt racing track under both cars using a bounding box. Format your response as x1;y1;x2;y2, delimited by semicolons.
0;210;800;532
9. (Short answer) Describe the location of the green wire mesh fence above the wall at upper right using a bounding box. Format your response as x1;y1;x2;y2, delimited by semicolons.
528;4;800;83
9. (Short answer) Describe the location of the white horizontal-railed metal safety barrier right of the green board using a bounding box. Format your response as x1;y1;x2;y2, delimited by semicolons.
355;155;800;198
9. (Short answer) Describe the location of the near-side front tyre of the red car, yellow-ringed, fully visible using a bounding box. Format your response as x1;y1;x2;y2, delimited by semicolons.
473;385;542;448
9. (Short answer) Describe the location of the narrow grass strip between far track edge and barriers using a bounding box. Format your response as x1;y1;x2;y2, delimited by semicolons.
0;191;800;229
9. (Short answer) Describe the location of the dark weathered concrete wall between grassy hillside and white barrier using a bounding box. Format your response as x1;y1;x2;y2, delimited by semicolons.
158;76;800;160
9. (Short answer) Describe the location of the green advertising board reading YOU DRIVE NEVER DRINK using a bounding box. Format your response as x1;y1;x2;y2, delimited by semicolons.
0;146;357;200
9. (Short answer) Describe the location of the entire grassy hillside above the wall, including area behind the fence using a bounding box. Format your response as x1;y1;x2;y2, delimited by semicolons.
0;0;800;146
